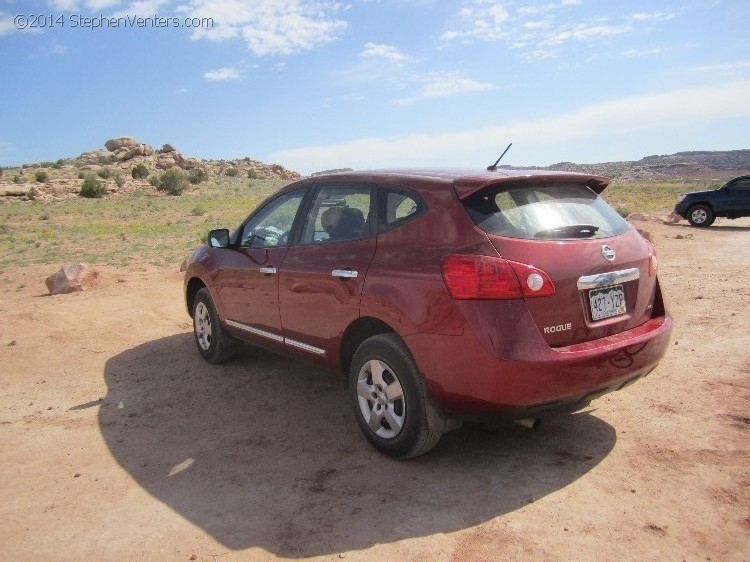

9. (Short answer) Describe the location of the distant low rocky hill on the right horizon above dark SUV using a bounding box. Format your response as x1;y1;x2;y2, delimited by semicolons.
500;149;750;182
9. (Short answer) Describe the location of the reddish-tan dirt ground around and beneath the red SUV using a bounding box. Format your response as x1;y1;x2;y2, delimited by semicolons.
0;219;750;561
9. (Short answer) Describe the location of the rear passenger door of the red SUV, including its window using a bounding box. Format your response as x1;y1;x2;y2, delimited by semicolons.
279;183;376;363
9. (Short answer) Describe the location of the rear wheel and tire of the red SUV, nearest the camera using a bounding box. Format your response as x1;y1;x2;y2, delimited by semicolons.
349;334;445;459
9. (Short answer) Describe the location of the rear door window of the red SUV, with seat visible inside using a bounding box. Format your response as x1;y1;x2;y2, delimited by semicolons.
302;186;372;244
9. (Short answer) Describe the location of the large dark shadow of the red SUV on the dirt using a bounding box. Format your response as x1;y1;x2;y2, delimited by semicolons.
100;334;616;557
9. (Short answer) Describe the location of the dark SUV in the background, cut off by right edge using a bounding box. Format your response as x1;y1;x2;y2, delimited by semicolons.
674;176;750;227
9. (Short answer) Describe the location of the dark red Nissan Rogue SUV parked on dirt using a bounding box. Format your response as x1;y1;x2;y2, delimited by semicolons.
185;169;672;458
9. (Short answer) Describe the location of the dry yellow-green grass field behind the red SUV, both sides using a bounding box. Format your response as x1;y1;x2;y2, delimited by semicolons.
0;177;704;269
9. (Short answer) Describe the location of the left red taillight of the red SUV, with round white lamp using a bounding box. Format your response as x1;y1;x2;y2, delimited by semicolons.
443;255;555;299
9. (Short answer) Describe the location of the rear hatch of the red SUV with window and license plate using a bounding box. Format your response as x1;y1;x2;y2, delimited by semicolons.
462;178;656;347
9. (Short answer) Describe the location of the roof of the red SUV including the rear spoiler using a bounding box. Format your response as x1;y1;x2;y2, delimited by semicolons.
304;168;609;199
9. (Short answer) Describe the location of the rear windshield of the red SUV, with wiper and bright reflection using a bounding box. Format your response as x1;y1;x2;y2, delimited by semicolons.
463;183;628;239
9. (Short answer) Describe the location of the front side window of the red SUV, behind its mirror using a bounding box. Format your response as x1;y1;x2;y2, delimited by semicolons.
240;190;305;248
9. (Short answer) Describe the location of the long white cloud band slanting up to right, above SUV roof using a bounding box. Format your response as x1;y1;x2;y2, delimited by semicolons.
270;80;750;172
